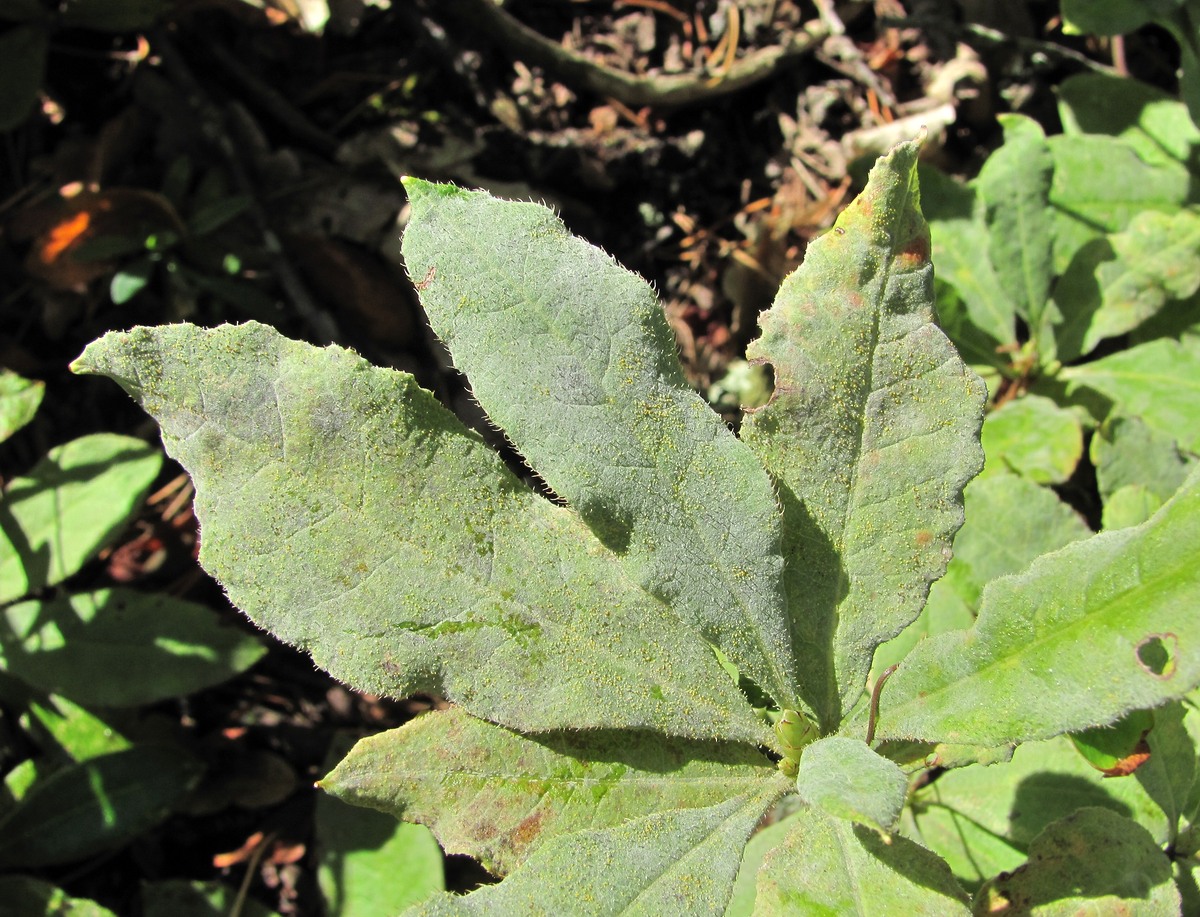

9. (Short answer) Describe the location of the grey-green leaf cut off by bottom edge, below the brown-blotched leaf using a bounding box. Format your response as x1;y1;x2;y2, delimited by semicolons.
404;784;779;917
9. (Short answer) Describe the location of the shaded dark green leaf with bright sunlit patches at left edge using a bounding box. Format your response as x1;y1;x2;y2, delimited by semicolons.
0;589;266;707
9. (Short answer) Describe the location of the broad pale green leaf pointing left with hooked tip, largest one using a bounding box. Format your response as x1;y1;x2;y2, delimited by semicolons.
76;324;763;742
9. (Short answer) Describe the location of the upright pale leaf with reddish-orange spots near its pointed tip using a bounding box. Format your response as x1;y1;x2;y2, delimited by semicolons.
743;143;986;730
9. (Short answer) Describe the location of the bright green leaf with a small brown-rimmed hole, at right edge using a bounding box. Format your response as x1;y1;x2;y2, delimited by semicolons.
878;460;1200;745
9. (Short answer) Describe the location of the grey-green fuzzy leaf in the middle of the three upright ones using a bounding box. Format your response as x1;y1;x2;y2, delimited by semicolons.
403;179;797;707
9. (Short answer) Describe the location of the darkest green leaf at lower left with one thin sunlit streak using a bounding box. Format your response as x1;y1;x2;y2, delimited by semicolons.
0;744;203;869
